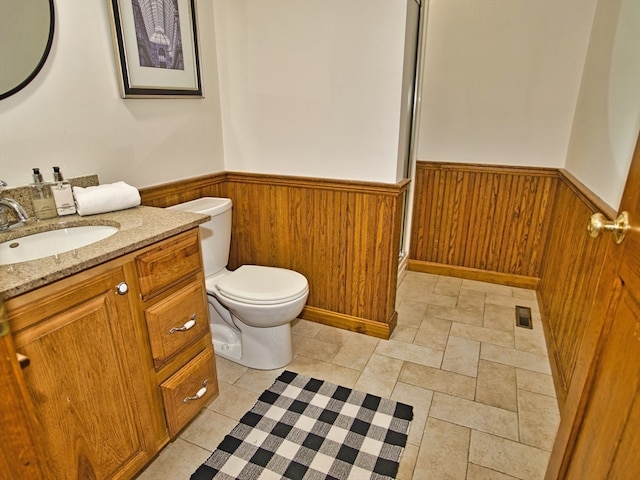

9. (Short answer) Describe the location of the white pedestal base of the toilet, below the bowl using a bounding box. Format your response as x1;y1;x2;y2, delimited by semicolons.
209;323;293;370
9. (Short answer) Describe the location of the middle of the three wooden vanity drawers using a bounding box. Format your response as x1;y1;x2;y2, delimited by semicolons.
144;273;209;370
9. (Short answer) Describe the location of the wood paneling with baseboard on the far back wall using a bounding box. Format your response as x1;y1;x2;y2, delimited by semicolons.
409;161;557;288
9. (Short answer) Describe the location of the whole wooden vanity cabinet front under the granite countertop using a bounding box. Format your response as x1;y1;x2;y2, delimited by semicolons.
6;228;218;480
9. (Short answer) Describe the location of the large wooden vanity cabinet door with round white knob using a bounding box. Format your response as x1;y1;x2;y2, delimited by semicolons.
10;267;156;479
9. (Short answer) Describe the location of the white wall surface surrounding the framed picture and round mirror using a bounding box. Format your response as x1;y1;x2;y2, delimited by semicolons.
0;0;224;187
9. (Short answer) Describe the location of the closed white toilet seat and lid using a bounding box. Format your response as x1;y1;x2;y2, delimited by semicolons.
215;265;309;305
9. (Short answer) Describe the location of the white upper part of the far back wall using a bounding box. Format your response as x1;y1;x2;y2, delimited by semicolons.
417;0;596;167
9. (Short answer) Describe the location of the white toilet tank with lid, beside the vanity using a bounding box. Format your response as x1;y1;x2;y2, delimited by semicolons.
167;197;232;277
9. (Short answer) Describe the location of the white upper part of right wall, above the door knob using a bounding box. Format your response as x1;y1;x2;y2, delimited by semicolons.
566;0;640;209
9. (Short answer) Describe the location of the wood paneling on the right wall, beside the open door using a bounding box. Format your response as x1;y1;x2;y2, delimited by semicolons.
538;170;616;405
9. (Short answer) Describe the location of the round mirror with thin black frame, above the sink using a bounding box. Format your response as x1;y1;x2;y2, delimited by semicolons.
0;0;55;100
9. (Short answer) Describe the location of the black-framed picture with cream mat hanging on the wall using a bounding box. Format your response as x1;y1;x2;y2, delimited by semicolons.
109;0;203;98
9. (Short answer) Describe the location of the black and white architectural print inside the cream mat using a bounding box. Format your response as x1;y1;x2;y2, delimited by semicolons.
131;0;184;70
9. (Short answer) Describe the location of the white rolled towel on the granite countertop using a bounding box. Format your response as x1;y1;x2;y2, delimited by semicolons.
73;182;141;215
